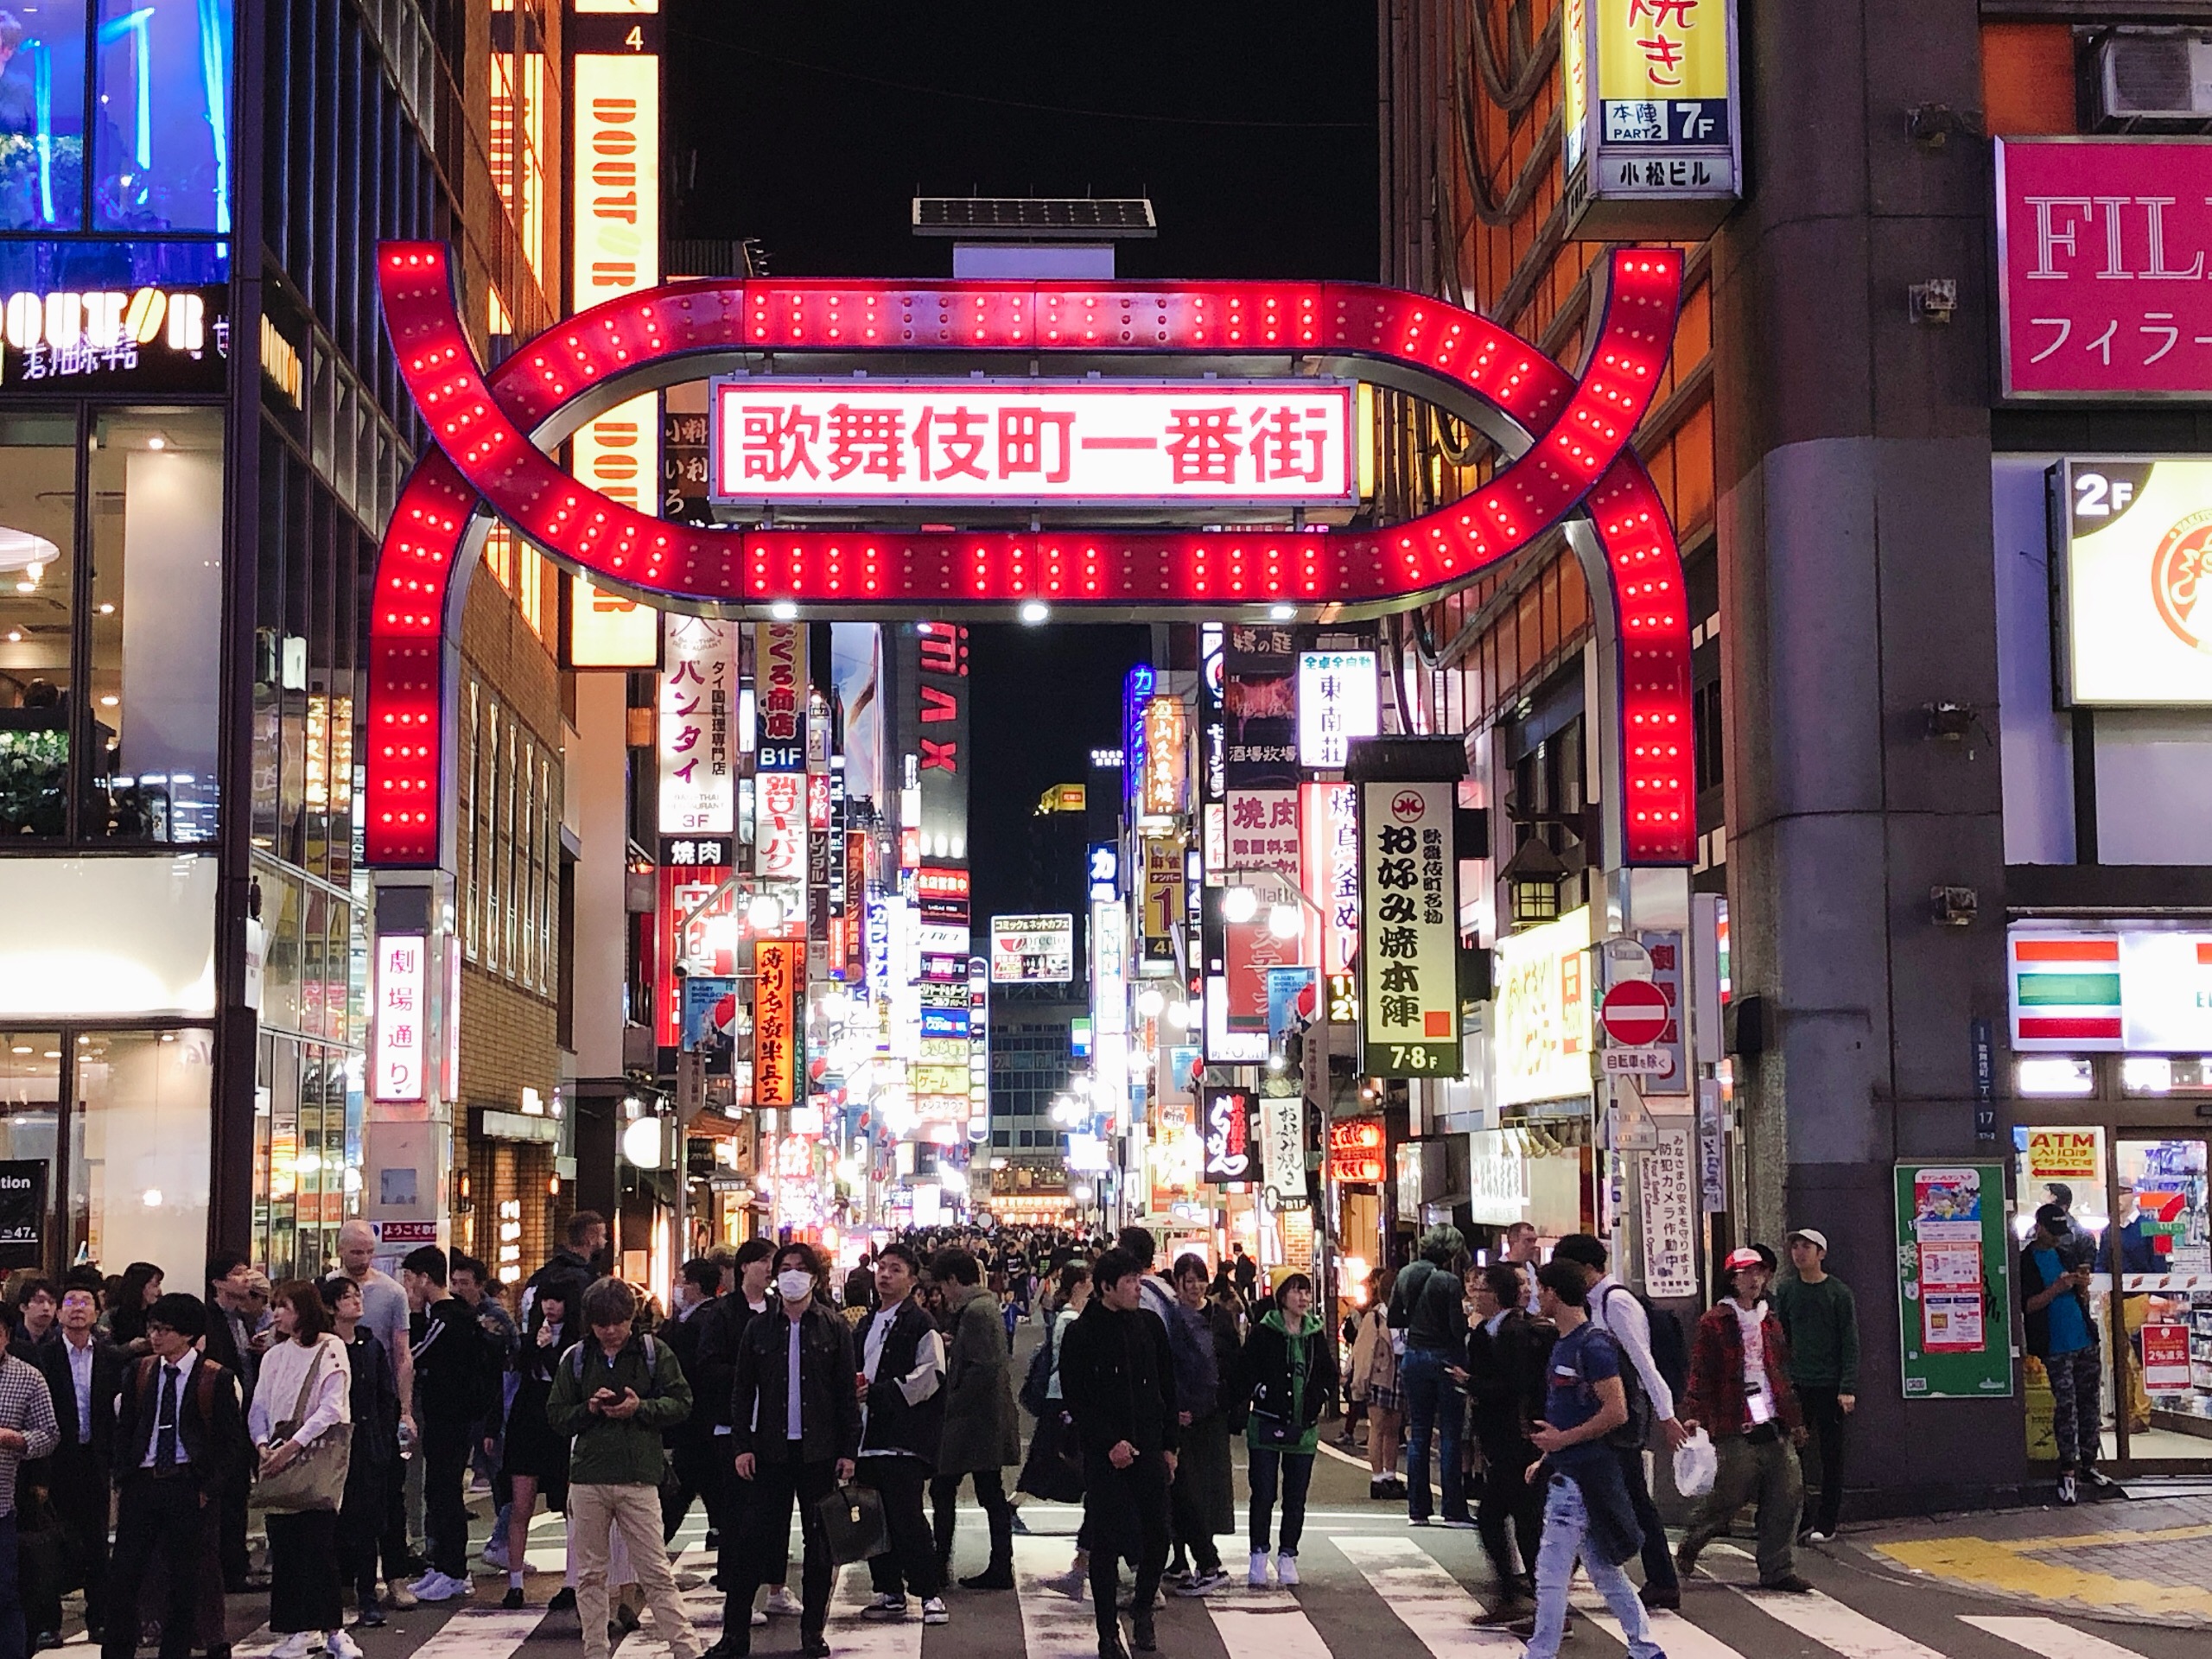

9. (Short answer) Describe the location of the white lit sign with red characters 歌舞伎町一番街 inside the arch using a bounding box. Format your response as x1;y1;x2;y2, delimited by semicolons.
712;380;1358;506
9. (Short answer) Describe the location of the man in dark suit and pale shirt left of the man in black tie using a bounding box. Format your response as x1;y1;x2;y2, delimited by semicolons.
29;1285;128;1648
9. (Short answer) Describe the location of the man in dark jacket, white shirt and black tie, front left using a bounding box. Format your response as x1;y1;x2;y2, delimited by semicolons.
99;1292;248;1659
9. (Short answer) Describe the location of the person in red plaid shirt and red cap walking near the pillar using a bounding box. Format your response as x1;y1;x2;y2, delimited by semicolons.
1675;1249;1812;1595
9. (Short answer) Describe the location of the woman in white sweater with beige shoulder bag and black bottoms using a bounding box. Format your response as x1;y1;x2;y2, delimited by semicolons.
245;1279;360;1659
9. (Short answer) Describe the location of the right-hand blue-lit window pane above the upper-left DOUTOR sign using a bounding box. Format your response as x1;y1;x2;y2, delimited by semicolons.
93;0;232;234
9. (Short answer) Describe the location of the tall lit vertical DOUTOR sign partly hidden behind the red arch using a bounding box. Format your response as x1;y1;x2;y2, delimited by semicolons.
556;0;661;668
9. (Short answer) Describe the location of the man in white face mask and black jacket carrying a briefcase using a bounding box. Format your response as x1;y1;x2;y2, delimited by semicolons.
712;1243;861;1659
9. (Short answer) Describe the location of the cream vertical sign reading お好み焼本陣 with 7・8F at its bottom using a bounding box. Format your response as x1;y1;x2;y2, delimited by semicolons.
1358;783;1460;1077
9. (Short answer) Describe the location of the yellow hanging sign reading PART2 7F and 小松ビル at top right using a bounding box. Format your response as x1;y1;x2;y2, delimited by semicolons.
1560;0;1743;241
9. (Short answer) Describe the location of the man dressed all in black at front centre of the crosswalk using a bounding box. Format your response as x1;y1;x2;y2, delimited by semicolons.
1059;1249;1181;1659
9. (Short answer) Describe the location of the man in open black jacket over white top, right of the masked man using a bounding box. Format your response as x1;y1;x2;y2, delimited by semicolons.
845;1241;947;1624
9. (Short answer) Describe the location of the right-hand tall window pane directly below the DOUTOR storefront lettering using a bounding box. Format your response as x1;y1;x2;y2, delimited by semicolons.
79;410;224;845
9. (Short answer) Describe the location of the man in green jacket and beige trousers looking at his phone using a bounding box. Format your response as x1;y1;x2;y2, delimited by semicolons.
546;1279;702;1659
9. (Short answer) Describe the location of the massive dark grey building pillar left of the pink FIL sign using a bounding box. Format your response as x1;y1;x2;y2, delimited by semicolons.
1712;0;2026;1513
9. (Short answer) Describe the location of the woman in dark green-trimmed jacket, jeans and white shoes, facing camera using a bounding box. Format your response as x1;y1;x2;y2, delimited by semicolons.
1243;1274;1336;1591
